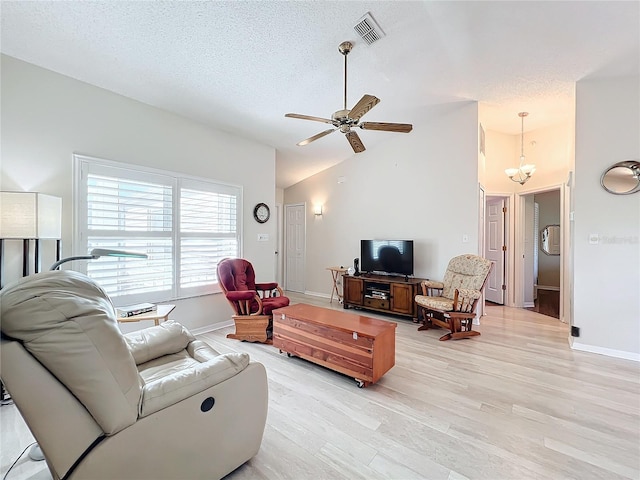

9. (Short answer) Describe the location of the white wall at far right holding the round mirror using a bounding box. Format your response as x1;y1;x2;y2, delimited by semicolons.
573;77;640;360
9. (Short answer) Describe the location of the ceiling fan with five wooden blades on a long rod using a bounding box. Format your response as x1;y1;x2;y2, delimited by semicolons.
285;42;413;153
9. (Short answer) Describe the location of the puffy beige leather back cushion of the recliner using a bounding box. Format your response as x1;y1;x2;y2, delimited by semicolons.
0;270;142;435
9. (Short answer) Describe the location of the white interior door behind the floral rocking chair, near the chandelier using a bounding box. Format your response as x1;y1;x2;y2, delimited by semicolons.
485;198;506;305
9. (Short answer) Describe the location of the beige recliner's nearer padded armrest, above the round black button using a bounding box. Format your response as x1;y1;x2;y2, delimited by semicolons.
140;352;249;417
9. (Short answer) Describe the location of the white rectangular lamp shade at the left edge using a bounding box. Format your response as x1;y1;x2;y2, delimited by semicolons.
0;192;62;239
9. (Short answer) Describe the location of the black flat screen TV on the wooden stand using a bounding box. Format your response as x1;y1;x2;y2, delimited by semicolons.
360;240;413;276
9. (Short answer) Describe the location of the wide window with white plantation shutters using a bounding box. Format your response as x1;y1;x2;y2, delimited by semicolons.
72;155;242;304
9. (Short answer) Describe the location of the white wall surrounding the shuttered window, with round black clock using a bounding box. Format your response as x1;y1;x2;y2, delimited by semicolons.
0;56;276;329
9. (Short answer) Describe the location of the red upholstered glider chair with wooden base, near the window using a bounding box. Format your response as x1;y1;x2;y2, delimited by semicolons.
217;258;289;343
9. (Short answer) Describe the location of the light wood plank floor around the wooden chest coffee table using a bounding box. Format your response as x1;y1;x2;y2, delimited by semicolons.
0;294;640;480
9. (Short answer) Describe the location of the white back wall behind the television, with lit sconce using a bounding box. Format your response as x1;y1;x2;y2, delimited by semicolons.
284;102;478;295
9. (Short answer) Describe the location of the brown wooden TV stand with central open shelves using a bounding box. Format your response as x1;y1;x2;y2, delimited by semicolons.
343;274;425;320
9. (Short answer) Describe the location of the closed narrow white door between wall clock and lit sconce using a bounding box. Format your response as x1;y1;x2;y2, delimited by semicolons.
284;204;306;293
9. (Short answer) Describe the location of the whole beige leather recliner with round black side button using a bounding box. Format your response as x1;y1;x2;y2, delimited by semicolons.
0;270;268;479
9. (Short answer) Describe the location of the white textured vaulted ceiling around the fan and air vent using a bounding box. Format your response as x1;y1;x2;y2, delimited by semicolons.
0;0;640;188
